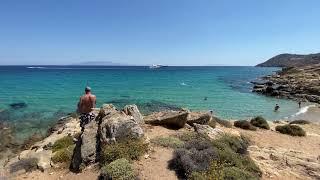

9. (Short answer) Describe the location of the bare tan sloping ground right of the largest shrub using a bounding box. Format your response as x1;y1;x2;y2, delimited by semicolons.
238;123;320;179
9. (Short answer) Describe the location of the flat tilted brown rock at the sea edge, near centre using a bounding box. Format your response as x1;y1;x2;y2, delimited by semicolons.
144;111;188;128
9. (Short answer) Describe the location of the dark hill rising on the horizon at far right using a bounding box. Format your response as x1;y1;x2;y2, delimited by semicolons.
256;53;320;67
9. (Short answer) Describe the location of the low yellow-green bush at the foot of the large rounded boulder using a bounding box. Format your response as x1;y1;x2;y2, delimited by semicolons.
101;139;148;164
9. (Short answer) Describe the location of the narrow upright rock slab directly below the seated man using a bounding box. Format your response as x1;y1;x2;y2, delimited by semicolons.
81;121;98;164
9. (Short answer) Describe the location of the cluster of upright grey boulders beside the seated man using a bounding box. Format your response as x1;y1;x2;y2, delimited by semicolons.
70;104;144;172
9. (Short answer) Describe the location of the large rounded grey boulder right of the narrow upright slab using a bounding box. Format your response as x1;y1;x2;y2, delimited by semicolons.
99;112;144;143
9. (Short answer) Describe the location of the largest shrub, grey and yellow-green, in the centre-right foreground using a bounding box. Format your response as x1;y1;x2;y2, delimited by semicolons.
170;135;262;180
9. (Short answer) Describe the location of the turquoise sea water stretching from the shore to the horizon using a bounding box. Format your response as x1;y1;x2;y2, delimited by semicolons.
0;66;298;141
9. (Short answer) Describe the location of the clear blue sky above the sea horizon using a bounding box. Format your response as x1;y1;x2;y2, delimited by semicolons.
0;0;320;65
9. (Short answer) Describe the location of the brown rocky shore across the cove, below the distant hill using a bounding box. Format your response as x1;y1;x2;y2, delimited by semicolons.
251;64;320;103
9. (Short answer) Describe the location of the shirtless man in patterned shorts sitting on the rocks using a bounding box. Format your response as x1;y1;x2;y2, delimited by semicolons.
78;86;96;129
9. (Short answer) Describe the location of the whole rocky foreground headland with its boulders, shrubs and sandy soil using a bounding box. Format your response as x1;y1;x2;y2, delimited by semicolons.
0;104;320;180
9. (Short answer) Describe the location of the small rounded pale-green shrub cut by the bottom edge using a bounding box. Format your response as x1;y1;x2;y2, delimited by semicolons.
99;158;136;180
